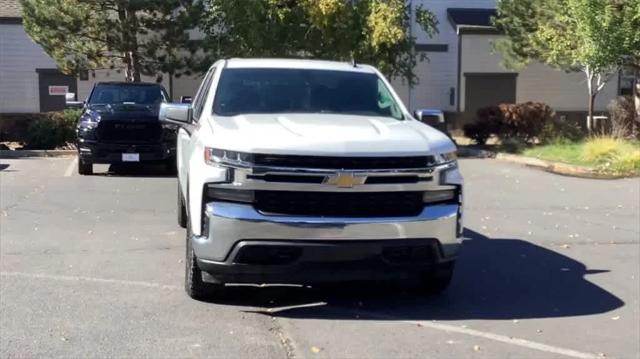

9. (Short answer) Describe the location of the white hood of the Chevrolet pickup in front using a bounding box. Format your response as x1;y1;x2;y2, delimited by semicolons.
208;114;455;156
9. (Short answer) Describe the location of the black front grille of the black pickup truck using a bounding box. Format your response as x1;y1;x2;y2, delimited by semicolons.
98;121;162;143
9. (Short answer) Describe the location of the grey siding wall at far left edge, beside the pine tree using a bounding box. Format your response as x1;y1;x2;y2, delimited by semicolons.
0;24;56;113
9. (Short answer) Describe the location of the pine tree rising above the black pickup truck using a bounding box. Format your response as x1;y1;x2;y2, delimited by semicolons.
22;0;202;91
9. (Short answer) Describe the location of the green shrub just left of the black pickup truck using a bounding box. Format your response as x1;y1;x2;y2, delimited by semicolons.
25;110;81;150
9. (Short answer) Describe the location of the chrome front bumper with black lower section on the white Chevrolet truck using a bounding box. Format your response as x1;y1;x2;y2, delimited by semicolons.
192;202;460;283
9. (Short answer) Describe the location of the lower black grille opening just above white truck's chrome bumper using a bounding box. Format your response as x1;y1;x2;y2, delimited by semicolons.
254;191;424;217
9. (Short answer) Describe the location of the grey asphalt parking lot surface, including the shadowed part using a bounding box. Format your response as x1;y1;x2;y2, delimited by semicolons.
0;158;640;358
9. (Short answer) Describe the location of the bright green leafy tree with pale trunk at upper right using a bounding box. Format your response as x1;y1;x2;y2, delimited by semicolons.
494;0;640;131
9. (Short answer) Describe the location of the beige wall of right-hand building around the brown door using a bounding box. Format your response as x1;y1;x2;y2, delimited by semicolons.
460;35;618;111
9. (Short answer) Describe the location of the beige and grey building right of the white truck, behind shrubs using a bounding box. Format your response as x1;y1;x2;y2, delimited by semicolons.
394;0;632;127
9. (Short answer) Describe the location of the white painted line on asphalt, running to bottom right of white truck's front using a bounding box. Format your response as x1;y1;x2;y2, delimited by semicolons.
354;311;602;359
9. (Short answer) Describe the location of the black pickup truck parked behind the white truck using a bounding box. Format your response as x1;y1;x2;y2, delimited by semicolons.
76;82;176;175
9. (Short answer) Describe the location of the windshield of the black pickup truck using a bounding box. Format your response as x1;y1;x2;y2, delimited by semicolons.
88;84;166;105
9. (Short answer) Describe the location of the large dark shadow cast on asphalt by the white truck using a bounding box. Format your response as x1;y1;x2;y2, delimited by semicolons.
211;229;624;320
